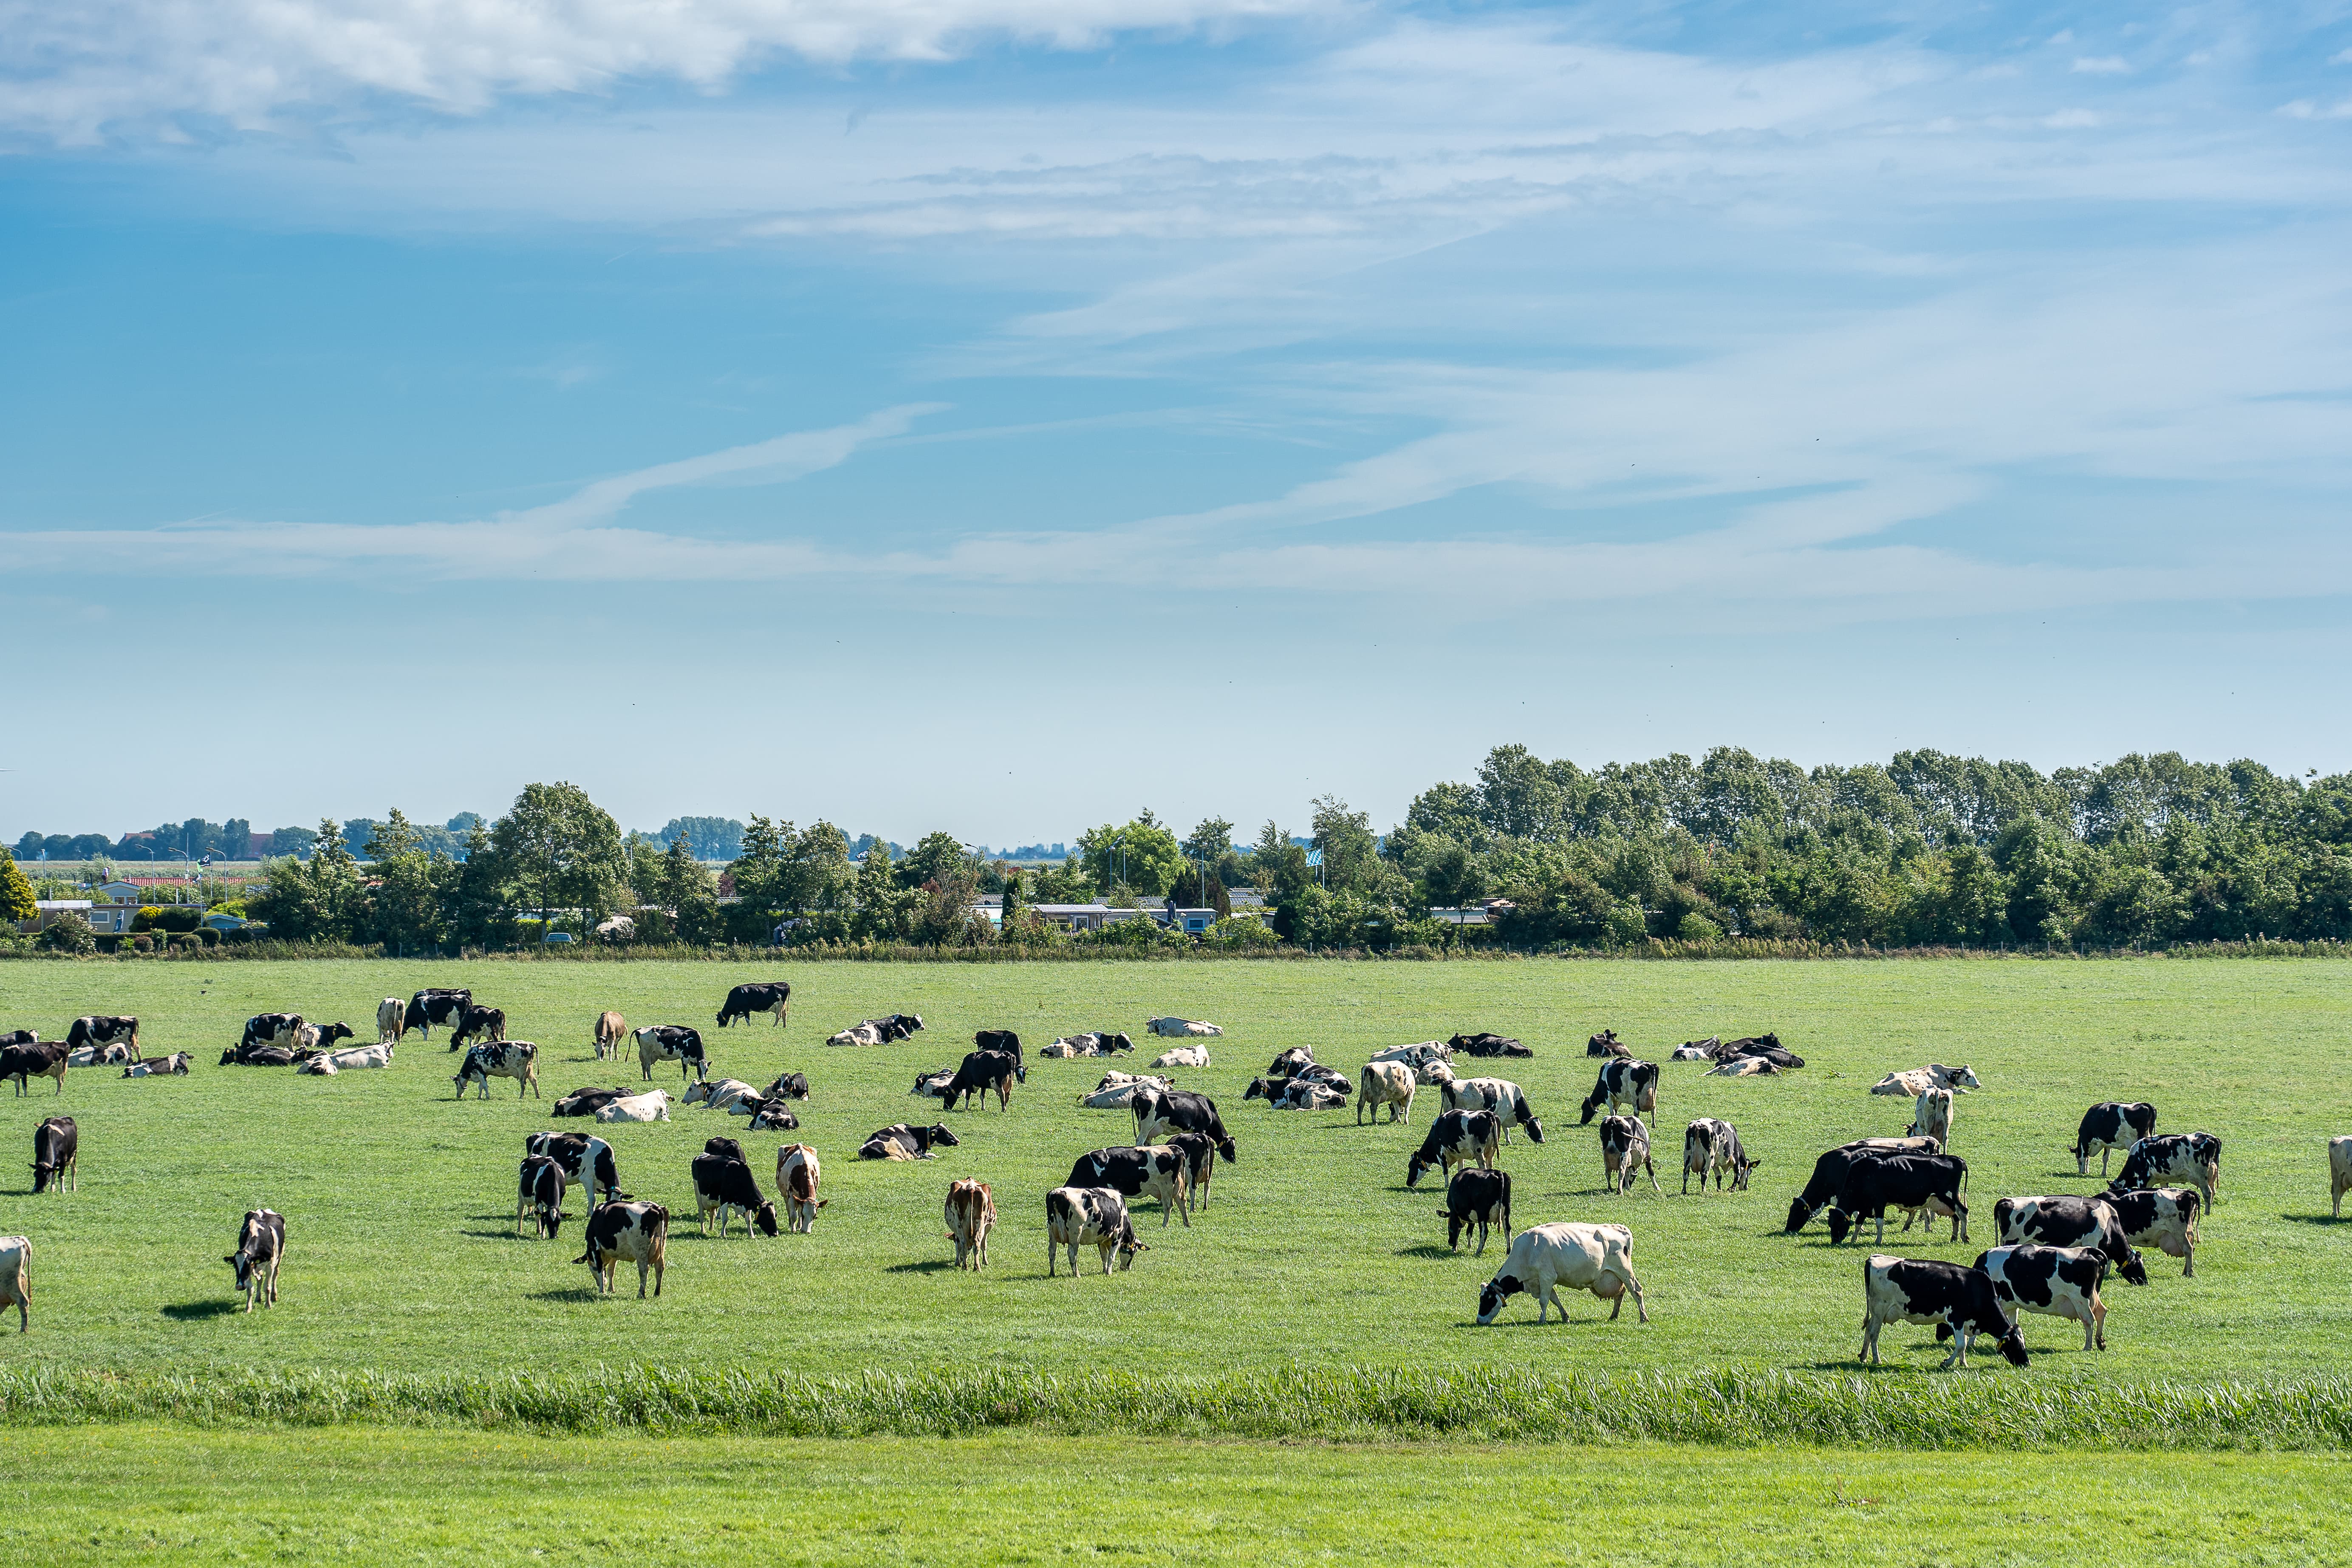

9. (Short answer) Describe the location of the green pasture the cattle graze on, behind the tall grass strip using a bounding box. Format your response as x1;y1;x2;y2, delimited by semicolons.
0;959;2352;1382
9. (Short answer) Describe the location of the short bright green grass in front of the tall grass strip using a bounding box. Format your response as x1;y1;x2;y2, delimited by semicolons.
0;1424;2352;1568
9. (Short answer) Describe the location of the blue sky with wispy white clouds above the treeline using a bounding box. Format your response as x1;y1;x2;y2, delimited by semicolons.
0;0;2352;844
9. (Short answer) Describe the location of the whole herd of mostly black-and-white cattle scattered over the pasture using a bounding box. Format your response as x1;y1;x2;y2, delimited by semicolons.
0;980;2352;1368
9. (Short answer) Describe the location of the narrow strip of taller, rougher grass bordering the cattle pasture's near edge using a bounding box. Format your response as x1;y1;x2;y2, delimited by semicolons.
0;1366;2352;1450
